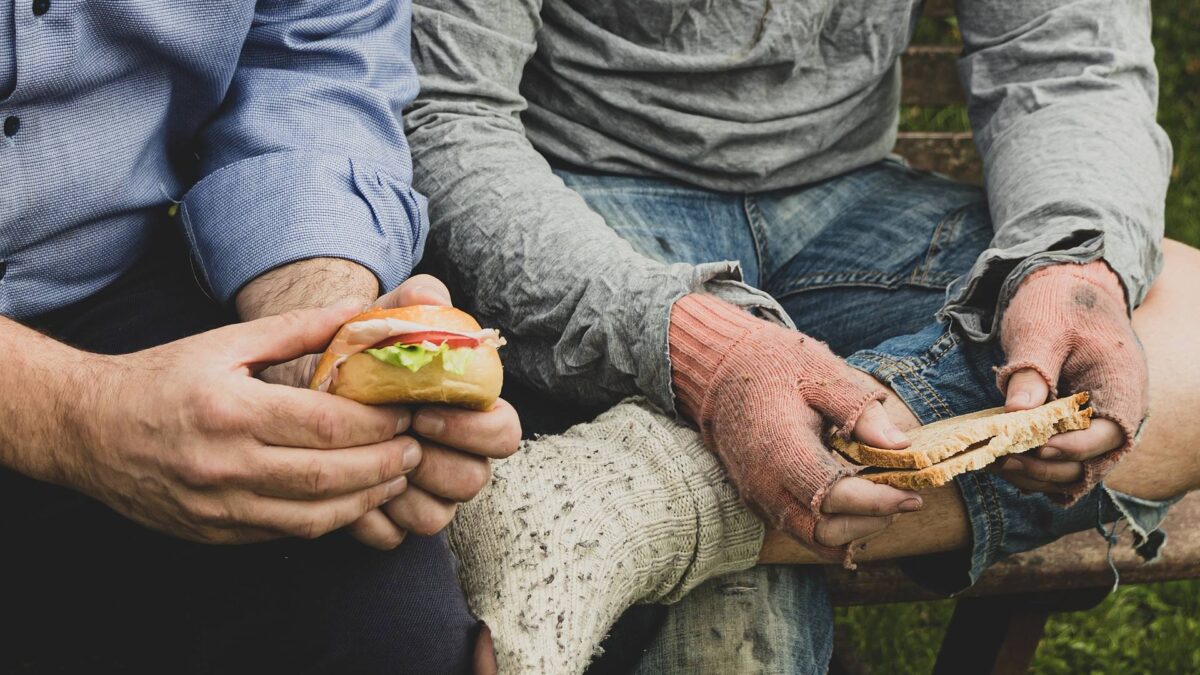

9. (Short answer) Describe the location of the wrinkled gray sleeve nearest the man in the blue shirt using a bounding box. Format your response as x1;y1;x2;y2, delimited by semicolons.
406;0;785;410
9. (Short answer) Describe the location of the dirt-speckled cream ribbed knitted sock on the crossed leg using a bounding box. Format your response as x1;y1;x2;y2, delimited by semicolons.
450;400;763;673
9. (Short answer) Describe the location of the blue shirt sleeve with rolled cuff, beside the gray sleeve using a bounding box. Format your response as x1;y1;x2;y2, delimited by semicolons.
181;0;427;301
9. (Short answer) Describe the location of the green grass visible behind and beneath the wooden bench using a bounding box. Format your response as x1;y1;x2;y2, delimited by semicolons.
836;0;1200;675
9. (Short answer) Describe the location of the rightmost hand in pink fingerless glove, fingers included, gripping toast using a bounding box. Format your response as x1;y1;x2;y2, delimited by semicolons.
996;261;1150;503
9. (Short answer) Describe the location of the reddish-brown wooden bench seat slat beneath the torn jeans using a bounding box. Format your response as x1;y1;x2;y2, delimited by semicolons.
827;492;1200;605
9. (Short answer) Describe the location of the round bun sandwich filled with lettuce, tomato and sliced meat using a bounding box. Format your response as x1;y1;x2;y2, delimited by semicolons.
308;305;504;410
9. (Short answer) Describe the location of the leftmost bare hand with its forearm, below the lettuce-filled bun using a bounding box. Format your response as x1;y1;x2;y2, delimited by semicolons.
0;302;420;543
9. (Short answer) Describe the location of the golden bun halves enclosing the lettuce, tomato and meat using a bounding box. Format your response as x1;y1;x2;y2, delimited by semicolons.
310;305;504;410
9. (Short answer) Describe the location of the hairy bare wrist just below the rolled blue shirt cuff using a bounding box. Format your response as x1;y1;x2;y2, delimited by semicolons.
234;258;379;321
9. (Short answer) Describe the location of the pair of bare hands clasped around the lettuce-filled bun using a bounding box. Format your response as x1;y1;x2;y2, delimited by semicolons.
56;275;521;549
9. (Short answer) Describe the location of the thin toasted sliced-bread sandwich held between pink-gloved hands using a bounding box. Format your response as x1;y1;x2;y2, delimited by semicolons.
828;392;1092;490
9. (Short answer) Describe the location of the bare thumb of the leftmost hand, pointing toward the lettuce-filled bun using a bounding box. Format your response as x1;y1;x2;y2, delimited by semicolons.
222;300;362;372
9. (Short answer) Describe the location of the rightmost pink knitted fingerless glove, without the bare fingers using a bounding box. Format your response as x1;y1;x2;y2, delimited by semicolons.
996;261;1150;503
